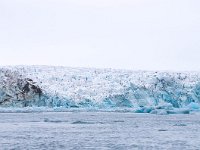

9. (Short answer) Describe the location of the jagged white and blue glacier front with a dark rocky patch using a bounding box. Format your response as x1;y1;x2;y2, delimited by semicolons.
0;66;200;113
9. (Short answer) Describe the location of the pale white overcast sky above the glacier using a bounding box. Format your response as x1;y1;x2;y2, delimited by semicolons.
0;0;200;70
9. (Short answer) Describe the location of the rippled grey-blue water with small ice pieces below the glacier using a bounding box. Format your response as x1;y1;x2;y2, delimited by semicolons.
0;112;200;150
